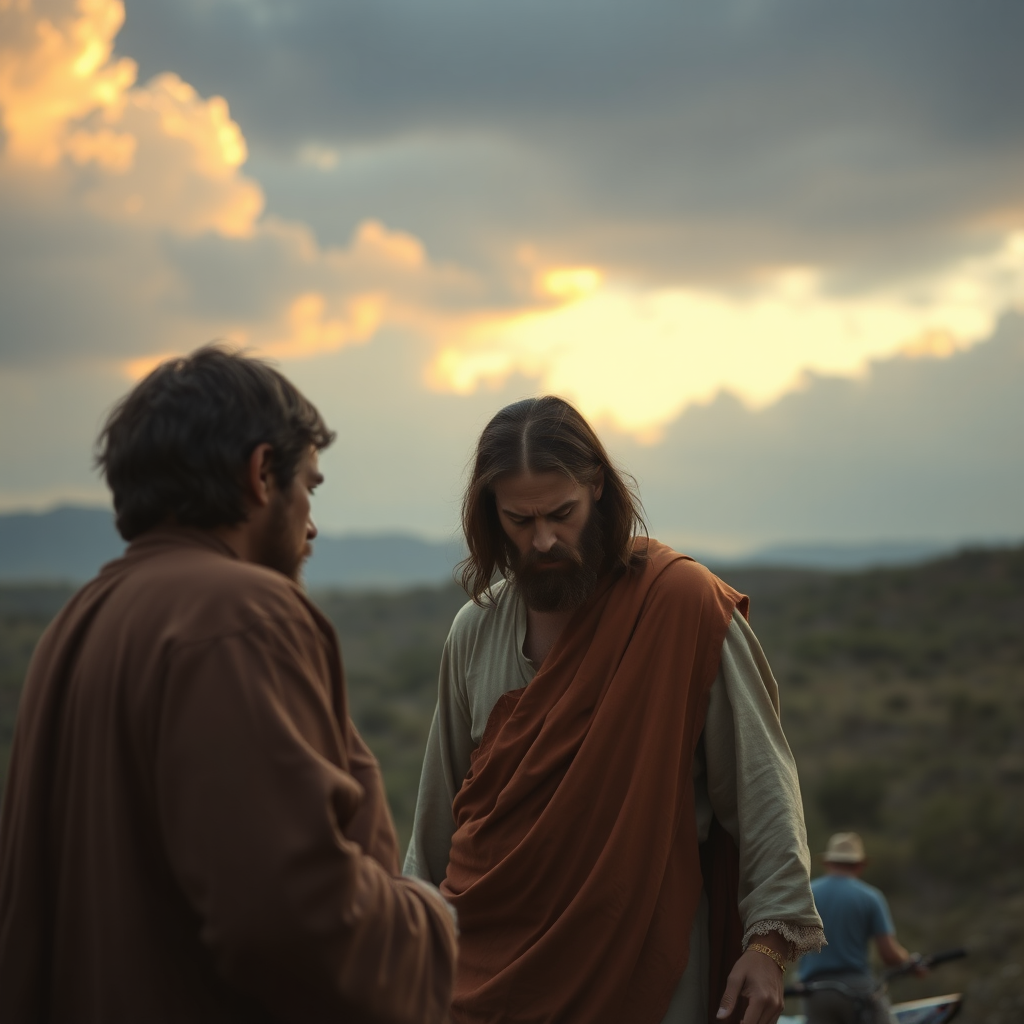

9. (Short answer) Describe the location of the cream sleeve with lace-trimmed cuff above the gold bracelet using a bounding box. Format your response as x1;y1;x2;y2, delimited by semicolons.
703;612;823;955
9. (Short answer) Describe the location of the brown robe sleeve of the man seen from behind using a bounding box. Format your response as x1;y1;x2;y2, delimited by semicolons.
154;621;456;1024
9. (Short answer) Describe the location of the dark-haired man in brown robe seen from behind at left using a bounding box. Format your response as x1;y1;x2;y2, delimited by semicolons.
0;347;456;1024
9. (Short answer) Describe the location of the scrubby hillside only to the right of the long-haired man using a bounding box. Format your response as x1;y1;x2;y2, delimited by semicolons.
729;549;1024;1022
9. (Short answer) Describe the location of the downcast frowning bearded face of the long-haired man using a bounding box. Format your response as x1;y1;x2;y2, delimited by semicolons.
495;472;604;611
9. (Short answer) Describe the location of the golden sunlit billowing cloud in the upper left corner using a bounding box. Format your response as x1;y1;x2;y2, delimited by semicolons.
0;0;263;238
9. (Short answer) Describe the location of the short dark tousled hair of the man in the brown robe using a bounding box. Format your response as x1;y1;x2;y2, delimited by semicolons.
96;345;335;541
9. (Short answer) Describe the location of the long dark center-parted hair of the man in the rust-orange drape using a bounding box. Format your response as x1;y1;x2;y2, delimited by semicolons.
456;395;647;604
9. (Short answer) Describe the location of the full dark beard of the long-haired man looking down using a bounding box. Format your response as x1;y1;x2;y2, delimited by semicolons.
508;507;604;611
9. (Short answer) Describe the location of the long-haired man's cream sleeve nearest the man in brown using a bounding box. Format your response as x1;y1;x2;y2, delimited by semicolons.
402;629;476;886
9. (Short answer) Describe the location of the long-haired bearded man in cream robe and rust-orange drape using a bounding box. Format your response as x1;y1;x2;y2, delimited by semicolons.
404;397;823;1024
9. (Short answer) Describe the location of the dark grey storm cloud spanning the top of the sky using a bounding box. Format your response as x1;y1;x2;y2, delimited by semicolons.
118;0;1024;290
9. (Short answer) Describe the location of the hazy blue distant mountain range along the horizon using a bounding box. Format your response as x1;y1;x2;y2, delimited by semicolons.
0;506;1007;590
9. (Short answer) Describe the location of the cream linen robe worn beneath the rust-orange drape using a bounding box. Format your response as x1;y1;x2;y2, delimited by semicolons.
403;582;824;1024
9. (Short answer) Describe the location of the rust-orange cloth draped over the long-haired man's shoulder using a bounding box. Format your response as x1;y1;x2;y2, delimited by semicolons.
441;541;746;1024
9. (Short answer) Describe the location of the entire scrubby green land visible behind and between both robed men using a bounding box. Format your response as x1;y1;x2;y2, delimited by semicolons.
0;548;1024;1024
